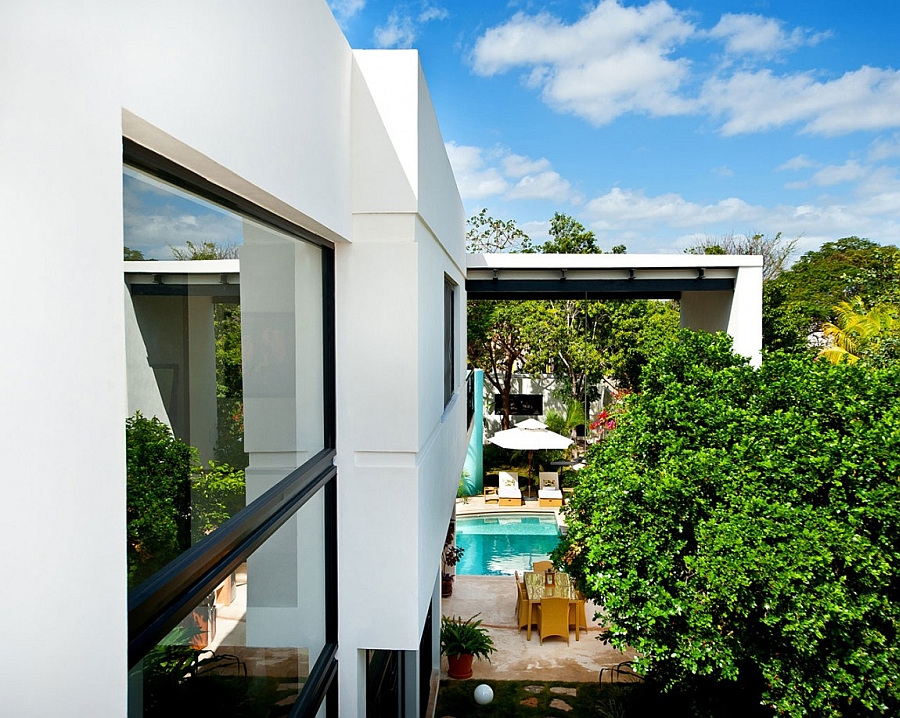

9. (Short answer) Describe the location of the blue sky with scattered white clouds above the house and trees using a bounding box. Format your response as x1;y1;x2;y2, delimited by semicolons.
330;0;900;253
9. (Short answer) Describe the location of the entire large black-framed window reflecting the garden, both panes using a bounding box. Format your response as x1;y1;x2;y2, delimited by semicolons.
123;142;337;716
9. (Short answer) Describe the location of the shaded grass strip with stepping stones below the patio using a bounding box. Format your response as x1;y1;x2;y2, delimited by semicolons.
435;680;772;718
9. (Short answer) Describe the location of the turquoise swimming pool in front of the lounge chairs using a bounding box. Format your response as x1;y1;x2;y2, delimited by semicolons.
456;512;559;576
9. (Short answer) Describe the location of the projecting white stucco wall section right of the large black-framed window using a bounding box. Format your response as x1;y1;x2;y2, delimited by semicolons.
336;51;466;715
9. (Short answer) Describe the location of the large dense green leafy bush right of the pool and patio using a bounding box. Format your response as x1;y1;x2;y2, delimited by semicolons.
556;331;900;716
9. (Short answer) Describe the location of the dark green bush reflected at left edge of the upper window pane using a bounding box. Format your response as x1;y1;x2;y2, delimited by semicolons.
125;412;197;586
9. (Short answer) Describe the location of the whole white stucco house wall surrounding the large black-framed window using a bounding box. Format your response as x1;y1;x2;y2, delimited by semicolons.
0;0;464;717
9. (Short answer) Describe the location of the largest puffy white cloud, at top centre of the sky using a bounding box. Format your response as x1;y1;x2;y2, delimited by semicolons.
472;0;695;125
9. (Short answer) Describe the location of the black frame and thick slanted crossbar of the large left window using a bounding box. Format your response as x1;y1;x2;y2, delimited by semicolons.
122;138;338;718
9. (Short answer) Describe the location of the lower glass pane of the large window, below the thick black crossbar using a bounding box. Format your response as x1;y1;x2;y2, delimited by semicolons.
129;492;325;718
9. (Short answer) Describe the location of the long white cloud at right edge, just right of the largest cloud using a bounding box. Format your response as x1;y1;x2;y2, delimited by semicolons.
703;67;900;135
